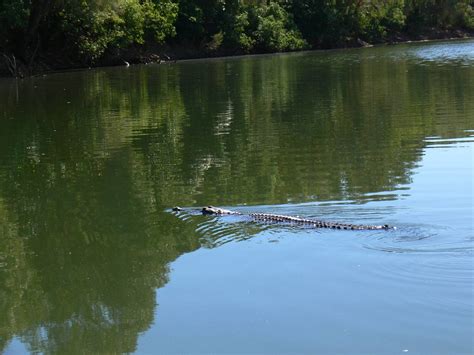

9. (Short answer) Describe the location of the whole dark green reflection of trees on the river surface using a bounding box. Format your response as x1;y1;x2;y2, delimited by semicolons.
0;52;474;352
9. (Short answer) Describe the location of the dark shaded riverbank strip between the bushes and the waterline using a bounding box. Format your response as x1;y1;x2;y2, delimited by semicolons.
0;28;474;78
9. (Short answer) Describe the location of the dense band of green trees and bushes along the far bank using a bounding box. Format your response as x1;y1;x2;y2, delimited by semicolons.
0;0;474;74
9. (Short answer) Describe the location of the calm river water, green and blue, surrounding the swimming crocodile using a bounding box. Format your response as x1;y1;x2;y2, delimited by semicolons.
0;41;474;354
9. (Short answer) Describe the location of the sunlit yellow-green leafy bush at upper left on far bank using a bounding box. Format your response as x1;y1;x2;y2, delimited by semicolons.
61;0;178;62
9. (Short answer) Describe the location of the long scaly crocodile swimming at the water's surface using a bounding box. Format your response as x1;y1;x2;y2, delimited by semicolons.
173;206;395;230
